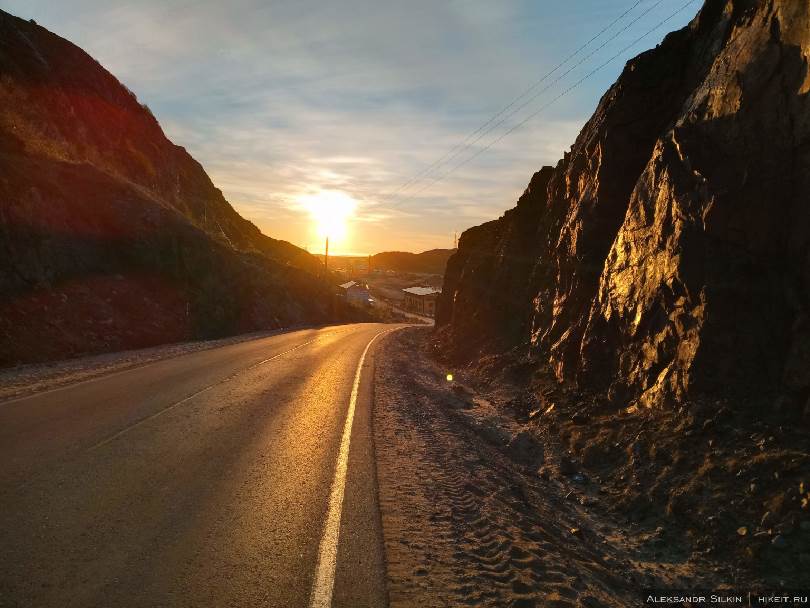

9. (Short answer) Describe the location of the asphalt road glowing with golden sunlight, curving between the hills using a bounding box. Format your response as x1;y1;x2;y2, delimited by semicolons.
0;324;392;608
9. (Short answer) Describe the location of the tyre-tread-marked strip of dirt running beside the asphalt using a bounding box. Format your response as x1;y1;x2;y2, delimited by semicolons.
374;331;644;608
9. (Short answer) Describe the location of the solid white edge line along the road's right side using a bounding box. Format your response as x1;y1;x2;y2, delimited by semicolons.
309;328;400;608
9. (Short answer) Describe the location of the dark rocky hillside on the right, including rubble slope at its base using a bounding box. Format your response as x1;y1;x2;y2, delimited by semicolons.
432;0;810;588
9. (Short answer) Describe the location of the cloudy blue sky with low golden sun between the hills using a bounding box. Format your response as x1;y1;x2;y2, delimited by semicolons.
0;0;701;254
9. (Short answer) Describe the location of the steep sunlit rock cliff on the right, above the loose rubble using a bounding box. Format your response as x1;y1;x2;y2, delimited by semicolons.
438;0;810;408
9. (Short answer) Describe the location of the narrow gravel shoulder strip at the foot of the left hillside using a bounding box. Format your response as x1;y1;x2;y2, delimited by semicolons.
0;329;302;401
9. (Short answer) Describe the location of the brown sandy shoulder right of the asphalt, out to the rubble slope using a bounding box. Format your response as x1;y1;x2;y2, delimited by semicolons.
374;329;713;608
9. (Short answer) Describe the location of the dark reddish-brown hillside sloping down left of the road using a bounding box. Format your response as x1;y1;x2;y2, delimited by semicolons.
0;11;331;365
